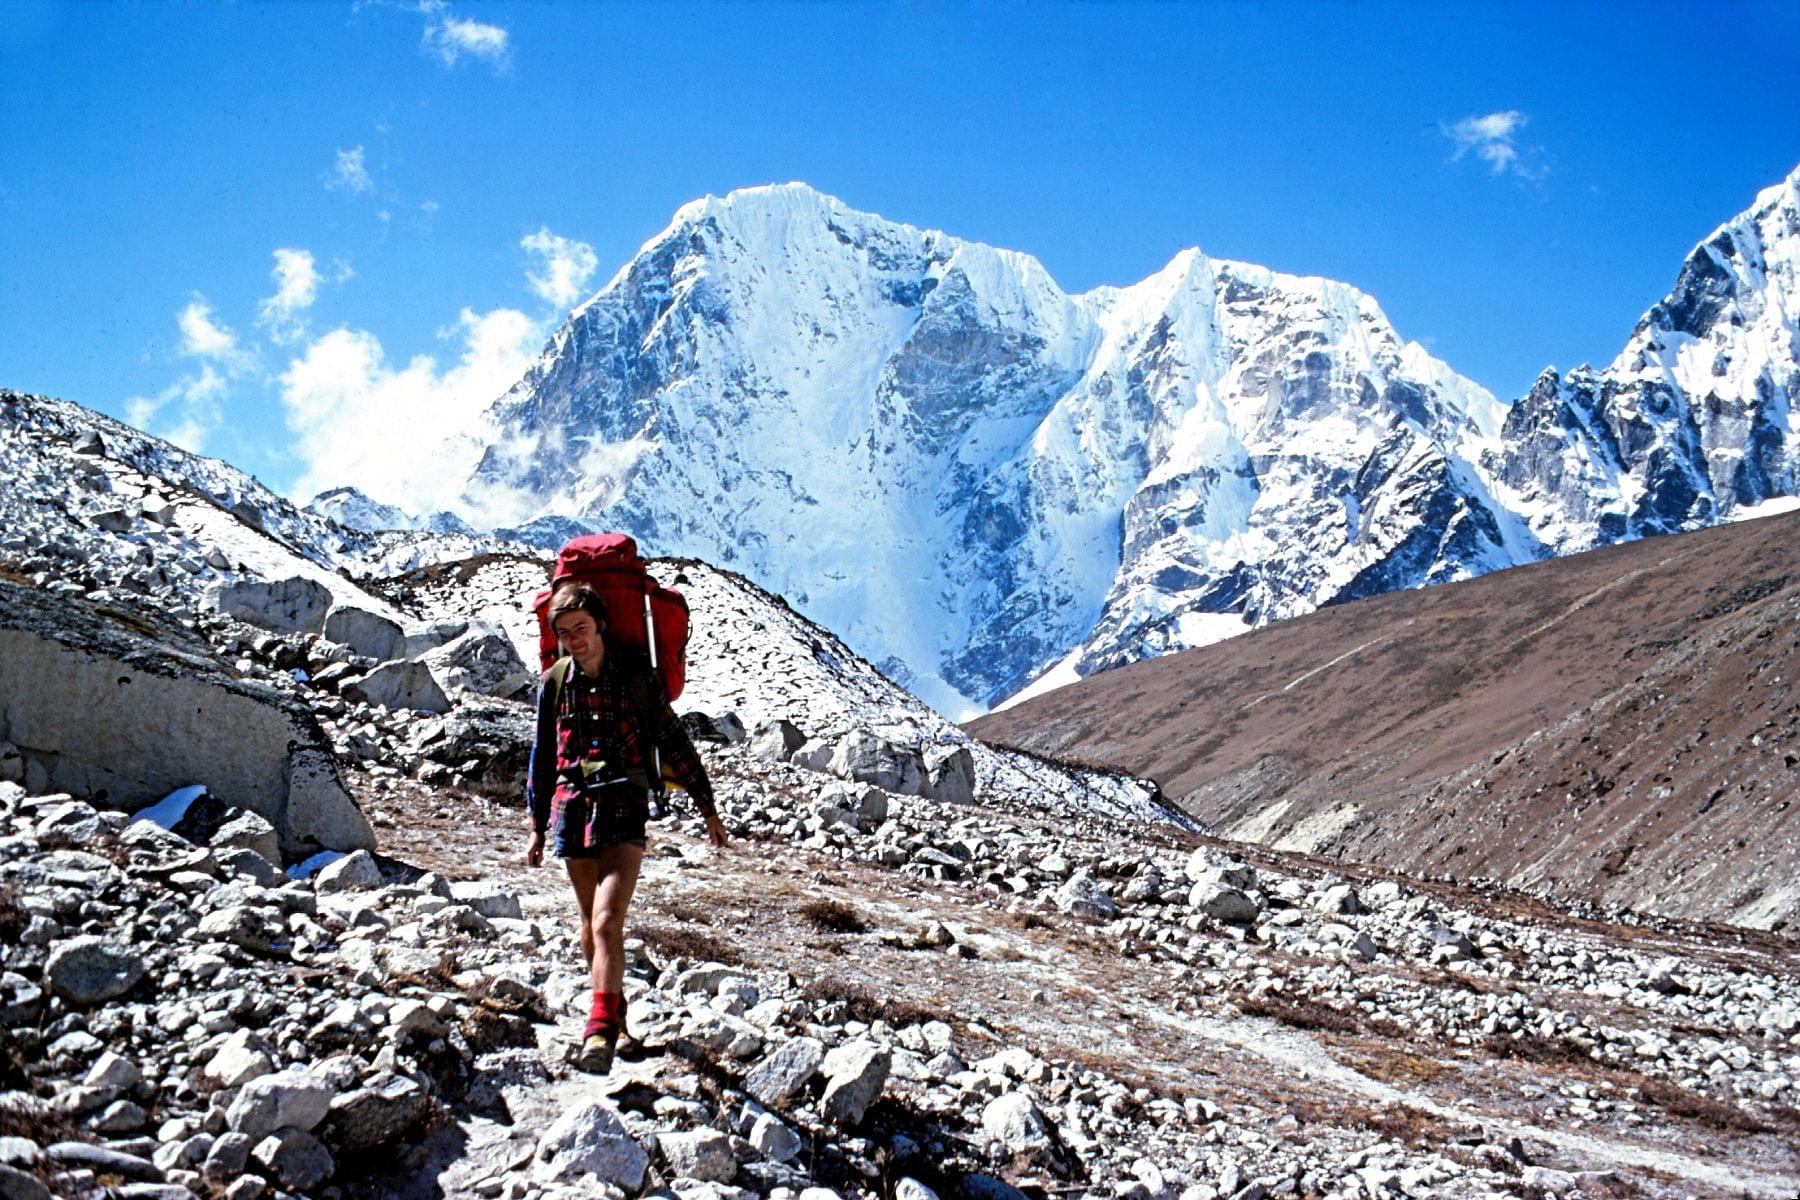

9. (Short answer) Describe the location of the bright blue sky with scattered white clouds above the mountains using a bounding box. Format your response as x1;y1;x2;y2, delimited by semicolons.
0;0;1800;498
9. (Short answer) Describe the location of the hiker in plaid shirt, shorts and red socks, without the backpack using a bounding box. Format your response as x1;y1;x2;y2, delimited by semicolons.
526;583;729;1074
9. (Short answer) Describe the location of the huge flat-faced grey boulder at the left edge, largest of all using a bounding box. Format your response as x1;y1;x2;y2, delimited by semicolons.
0;579;374;858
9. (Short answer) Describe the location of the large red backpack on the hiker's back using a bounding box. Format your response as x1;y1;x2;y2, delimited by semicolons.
531;533;688;700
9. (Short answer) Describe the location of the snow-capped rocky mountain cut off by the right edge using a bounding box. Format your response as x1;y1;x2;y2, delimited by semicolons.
1483;169;1800;554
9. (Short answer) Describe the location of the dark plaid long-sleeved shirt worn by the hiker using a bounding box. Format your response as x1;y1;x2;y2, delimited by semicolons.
526;653;716;833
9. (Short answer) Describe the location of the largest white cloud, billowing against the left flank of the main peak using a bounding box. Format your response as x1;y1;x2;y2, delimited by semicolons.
281;308;544;513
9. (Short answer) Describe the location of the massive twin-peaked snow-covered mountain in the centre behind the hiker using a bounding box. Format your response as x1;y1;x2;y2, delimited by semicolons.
472;185;1537;714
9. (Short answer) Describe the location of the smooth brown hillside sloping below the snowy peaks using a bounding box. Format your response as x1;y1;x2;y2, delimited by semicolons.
970;515;1800;928
